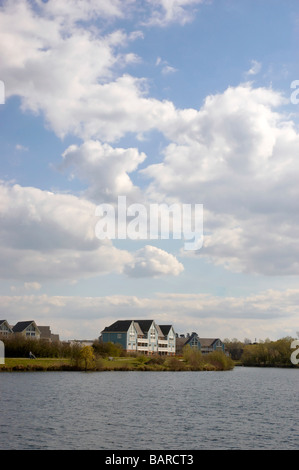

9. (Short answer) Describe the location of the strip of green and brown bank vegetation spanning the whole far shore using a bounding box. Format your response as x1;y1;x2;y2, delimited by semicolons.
0;337;299;371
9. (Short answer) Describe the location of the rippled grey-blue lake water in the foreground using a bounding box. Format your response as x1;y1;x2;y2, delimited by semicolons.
0;367;299;450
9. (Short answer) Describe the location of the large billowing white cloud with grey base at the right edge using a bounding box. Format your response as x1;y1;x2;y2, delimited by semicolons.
142;84;299;275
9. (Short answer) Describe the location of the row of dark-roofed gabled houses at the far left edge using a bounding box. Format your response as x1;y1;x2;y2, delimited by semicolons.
0;320;59;342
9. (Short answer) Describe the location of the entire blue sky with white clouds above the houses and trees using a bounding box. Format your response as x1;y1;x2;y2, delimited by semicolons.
0;0;299;341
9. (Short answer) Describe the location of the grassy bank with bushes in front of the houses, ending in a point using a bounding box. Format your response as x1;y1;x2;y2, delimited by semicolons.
0;337;234;371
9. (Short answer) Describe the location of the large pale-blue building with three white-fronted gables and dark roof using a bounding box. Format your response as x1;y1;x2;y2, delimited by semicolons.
100;320;176;355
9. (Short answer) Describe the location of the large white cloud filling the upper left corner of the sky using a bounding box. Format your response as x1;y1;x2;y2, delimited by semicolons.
0;0;189;142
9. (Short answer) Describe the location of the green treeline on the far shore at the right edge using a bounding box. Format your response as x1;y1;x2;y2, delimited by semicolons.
224;337;294;367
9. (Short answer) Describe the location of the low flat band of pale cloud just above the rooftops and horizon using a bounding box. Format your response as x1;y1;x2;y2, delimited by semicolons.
0;289;299;341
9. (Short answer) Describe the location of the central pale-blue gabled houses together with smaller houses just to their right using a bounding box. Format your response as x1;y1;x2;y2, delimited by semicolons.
99;320;225;356
